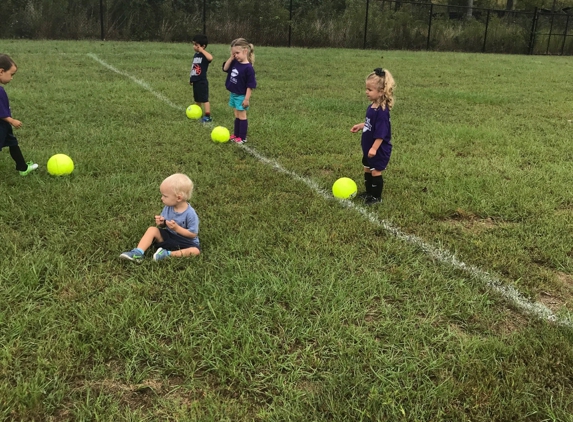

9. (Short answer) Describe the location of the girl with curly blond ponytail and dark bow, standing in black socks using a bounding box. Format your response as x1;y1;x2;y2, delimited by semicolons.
350;68;396;205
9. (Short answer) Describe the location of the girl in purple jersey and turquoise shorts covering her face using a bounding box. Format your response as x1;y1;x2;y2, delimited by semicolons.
223;38;257;144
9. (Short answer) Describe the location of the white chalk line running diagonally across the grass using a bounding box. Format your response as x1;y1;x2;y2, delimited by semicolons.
88;53;573;327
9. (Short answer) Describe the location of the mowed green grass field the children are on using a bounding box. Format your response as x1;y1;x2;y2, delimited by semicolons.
0;40;573;421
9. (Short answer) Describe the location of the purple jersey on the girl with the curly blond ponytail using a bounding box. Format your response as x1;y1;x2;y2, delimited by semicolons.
362;105;392;170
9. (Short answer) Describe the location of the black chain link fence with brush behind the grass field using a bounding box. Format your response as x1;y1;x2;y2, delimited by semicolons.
0;0;573;55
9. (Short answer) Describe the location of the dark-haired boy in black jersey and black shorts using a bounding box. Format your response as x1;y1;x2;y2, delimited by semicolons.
189;34;213;123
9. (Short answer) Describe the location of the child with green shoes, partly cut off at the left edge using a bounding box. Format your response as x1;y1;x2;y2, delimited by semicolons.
0;54;38;176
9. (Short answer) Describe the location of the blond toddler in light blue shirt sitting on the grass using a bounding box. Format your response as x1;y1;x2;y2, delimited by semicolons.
119;173;201;263
